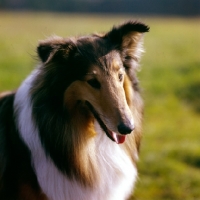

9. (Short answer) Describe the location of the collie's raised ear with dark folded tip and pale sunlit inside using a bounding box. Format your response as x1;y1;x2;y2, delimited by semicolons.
105;21;149;68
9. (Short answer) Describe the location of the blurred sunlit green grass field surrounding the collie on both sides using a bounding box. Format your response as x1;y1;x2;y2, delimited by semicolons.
0;12;200;200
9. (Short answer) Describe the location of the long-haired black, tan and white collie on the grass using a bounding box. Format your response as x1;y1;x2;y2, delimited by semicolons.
0;21;149;200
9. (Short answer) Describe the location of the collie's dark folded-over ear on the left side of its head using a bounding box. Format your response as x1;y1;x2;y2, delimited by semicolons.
37;36;75;63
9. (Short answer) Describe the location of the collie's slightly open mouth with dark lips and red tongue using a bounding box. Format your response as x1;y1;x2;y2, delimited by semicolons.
85;101;126;144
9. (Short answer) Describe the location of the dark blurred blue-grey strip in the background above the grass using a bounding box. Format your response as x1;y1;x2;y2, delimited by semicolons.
0;0;200;16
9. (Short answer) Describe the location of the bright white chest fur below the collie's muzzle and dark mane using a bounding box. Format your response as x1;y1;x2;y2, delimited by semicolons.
33;125;137;200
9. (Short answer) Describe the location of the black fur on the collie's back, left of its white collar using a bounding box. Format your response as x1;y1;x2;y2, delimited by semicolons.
0;94;41;200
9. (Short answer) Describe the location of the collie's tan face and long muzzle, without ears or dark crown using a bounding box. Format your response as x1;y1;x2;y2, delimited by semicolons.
64;51;134;143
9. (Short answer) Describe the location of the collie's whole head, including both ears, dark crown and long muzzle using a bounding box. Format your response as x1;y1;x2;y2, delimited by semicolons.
35;22;148;143
